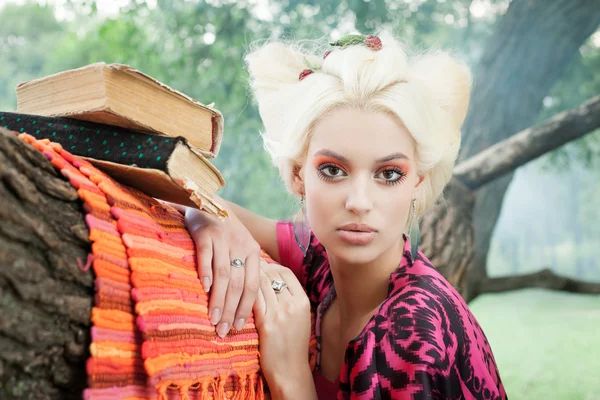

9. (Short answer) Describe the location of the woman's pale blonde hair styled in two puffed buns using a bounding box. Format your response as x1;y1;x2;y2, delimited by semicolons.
246;33;471;228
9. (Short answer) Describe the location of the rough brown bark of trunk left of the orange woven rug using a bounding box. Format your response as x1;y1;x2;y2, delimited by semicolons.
0;128;93;399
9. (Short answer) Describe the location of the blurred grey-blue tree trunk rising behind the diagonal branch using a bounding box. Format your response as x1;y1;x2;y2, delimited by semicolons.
460;0;600;296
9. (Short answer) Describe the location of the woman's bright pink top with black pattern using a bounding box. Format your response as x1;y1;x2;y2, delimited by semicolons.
276;222;507;400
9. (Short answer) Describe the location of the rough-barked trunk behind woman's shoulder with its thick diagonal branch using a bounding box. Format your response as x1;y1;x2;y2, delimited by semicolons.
420;97;600;302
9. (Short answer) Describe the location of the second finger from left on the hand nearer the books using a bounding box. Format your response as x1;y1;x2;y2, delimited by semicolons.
208;240;231;325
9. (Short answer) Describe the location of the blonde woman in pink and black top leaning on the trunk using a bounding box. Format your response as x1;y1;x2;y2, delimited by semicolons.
186;32;506;399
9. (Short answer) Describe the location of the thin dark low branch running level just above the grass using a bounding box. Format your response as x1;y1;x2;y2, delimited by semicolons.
479;268;600;294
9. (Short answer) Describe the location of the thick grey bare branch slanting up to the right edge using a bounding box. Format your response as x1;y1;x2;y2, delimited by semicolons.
454;96;600;190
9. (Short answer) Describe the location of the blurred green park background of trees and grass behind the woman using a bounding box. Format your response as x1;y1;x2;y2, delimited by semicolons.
0;0;600;399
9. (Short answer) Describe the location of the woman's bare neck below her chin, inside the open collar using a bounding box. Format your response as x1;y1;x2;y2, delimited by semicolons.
329;238;404;330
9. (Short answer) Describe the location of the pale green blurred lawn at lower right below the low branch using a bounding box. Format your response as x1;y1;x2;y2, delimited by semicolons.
469;289;600;400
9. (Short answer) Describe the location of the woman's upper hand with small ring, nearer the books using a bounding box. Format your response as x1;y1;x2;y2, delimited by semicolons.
185;208;261;337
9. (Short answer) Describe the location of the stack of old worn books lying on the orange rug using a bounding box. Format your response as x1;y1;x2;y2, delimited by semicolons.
11;63;226;217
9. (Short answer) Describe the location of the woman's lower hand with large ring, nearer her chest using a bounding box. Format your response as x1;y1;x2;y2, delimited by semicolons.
254;260;313;388
